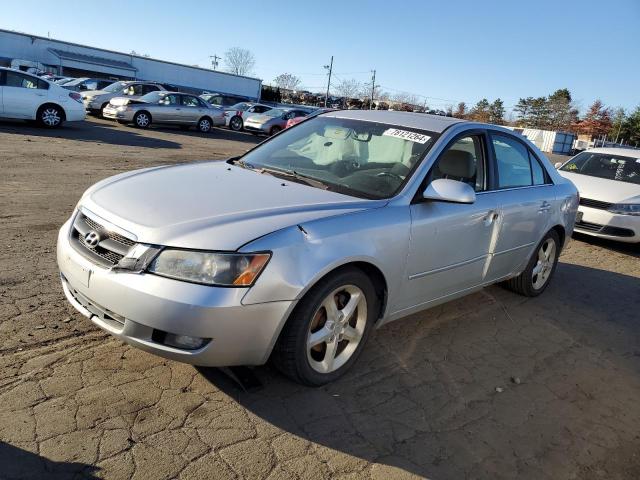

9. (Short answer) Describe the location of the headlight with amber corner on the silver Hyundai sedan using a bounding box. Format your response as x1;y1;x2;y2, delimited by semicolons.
147;248;271;287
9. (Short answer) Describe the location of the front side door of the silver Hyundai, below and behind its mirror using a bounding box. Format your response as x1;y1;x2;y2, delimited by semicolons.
401;130;499;309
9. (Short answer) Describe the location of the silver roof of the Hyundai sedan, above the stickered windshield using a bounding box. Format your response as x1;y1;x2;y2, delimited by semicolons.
322;110;462;133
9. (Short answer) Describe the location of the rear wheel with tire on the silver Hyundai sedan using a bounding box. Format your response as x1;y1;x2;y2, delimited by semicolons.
503;230;560;297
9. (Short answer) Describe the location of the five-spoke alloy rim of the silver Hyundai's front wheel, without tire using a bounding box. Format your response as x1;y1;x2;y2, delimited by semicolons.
307;285;367;373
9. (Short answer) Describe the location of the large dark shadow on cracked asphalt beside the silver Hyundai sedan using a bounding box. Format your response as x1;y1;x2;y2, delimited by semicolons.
198;263;640;478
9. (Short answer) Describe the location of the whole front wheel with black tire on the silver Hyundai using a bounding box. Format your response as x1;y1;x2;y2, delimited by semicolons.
271;267;379;386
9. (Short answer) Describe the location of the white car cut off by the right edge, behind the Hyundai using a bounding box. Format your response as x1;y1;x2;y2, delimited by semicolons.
556;148;640;243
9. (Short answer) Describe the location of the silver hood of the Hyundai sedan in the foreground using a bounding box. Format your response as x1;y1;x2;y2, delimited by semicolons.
80;161;386;250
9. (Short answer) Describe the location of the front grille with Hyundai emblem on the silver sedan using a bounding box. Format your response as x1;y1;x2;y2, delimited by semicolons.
70;212;136;267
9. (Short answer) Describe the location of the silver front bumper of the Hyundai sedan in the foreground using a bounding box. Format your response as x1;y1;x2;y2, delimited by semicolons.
57;221;295;366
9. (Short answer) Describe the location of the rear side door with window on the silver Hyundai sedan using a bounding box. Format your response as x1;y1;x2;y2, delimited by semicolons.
490;131;556;279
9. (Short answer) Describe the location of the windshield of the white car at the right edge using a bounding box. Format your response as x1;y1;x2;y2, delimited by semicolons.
561;151;640;185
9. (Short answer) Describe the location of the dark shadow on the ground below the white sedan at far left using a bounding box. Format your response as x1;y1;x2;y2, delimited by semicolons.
0;117;182;149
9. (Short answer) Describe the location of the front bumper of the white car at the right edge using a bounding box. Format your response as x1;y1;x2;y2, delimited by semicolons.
574;205;640;243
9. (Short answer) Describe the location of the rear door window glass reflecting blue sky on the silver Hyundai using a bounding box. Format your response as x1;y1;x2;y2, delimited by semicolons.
491;134;533;188
